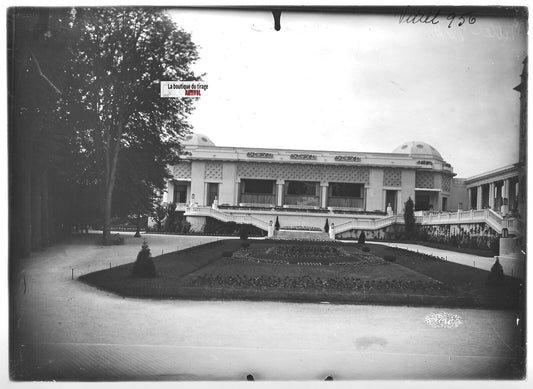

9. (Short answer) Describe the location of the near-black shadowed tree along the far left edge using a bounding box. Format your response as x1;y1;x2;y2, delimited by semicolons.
8;8;77;258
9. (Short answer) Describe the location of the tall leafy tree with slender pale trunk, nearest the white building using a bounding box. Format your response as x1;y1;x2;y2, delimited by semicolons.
60;8;199;243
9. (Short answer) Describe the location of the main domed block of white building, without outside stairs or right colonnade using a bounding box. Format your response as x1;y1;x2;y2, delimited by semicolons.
164;134;456;213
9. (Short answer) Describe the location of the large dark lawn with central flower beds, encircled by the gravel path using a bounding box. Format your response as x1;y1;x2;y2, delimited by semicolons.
80;240;519;309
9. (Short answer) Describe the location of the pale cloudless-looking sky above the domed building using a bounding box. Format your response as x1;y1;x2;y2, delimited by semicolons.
168;10;527;177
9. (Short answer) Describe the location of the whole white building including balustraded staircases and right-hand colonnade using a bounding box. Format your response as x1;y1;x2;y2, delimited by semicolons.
163;133;520;242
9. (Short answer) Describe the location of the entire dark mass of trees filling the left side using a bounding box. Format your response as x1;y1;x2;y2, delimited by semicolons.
8;7;199;253
